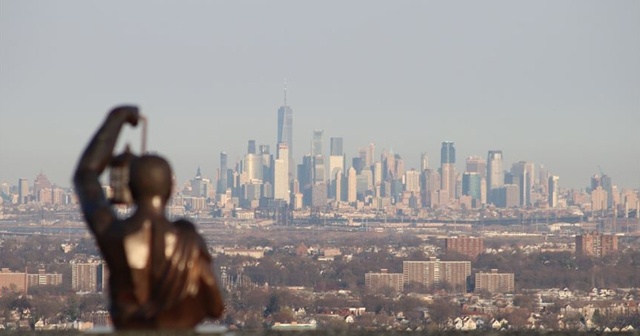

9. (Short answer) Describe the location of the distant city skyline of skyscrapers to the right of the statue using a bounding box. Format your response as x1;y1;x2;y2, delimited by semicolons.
190;100;638;218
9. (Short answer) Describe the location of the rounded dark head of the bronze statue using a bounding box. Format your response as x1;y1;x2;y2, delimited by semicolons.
129;155;173;204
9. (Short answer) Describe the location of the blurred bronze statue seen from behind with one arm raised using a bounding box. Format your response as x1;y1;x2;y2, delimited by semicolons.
74;106;224;330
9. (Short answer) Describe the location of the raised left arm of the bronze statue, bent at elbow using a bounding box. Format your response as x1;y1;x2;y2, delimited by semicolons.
73;106;139;236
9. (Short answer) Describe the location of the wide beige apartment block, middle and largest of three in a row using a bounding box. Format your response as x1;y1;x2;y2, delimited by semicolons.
402;258;471;292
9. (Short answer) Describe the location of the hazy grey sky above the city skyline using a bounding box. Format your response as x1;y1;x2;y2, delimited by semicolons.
0;0;640;188
